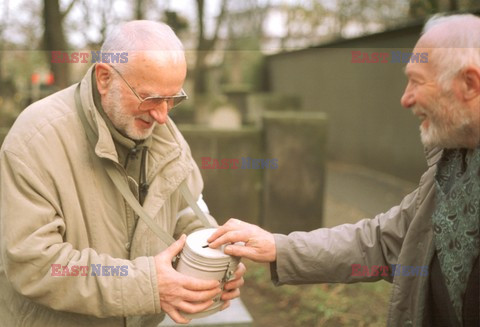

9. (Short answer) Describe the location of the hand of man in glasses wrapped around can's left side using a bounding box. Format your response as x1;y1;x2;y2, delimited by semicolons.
154;235;222;323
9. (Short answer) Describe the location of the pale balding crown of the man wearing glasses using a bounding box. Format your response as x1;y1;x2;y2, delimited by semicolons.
101;20;185;71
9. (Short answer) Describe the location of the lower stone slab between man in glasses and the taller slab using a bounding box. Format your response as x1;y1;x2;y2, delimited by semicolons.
179;125;263;227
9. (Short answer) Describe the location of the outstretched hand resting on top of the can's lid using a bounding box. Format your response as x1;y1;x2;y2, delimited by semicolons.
207;218;277;262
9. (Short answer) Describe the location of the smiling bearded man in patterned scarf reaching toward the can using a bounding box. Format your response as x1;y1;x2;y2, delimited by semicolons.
209;15;480;327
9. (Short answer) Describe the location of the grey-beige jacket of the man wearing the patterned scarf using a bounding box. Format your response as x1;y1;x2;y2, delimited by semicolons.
272;149;442;326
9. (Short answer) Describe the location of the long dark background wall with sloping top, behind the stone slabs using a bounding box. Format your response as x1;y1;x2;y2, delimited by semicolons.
267;24;426;181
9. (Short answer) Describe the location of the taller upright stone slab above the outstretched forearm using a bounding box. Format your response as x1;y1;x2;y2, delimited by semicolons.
262;112;327;234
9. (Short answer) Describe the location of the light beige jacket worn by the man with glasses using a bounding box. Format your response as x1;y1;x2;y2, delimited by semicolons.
0;69;208;327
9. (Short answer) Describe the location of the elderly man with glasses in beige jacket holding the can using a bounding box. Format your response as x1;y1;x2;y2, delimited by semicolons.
0;21;245;326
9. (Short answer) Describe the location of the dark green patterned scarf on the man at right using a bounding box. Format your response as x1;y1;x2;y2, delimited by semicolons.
432;147;480;322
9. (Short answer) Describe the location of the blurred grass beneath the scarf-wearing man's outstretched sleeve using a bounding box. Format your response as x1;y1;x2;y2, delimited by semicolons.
242;262;391;327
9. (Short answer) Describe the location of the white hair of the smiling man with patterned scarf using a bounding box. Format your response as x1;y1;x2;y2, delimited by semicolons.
422;14;480;89
